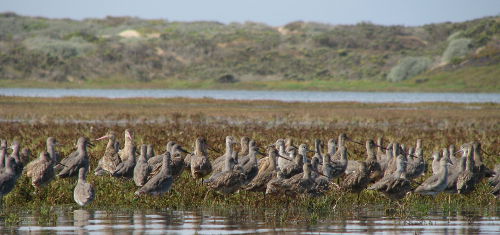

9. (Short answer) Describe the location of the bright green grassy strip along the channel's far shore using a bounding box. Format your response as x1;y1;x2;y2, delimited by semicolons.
0;65;500;93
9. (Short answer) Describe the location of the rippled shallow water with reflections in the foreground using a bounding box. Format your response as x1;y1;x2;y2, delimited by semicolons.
0;207;500;234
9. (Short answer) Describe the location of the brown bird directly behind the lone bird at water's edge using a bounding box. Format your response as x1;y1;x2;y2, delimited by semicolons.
57;137;93;178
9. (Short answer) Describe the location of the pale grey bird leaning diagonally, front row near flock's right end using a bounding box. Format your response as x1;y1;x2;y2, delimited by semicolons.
415;151;451;196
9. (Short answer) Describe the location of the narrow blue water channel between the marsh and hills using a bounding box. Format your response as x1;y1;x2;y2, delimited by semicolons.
0;88;500;103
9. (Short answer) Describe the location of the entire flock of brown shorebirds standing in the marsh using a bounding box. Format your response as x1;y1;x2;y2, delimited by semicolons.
0;129;500;206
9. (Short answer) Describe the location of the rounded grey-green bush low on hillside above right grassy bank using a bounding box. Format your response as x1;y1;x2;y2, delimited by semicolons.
387;57;432;82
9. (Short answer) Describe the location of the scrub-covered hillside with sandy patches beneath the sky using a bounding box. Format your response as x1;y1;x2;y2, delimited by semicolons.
0;13;500;92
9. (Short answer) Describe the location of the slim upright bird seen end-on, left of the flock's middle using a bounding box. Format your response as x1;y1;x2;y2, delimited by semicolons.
189;137;212;182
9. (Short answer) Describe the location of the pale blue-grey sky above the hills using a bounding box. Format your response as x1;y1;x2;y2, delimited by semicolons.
0;0;500;26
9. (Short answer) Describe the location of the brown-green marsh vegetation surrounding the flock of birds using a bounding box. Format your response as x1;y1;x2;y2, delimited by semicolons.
0;97;500;223
